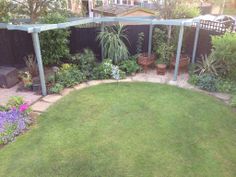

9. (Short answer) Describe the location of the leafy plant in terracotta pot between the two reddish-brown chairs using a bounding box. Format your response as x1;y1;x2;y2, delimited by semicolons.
156;43;173;75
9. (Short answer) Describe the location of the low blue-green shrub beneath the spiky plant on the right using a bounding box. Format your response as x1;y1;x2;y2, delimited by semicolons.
197;74;218;92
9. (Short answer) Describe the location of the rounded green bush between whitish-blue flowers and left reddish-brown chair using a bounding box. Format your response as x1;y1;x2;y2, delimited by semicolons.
119;58;140;75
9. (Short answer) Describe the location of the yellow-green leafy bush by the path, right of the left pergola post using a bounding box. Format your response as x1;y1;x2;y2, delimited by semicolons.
55;64;85;87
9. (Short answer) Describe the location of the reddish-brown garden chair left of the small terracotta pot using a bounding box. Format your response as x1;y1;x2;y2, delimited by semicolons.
138;53;155;72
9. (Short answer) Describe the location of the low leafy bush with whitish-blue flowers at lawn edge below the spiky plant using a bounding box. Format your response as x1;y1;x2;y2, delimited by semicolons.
93;59;125;79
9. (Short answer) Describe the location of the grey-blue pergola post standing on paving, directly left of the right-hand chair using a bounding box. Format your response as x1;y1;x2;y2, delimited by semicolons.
173;22;184;81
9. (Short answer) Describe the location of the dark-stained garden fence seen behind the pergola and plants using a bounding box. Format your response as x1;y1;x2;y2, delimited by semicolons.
0;25;221;67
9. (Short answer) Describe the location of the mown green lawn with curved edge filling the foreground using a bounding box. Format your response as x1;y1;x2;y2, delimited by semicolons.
0;83;236;177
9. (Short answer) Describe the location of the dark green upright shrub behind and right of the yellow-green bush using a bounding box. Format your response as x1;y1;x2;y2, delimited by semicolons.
71;49;96;79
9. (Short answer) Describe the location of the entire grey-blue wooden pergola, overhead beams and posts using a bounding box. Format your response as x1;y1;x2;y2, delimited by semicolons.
0;17;200;95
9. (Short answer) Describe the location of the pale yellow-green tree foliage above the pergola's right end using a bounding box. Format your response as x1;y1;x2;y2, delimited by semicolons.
173;3;200;19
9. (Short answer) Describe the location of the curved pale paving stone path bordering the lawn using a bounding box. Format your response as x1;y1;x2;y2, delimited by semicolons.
32;70;231;114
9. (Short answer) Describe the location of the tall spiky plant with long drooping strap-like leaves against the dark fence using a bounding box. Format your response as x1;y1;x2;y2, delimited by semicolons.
97;25;129;64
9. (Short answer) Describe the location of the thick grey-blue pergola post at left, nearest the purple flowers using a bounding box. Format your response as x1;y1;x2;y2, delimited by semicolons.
32;32;47;96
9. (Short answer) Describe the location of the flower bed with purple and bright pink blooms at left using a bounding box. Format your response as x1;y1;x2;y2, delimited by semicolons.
0;97;32;145
